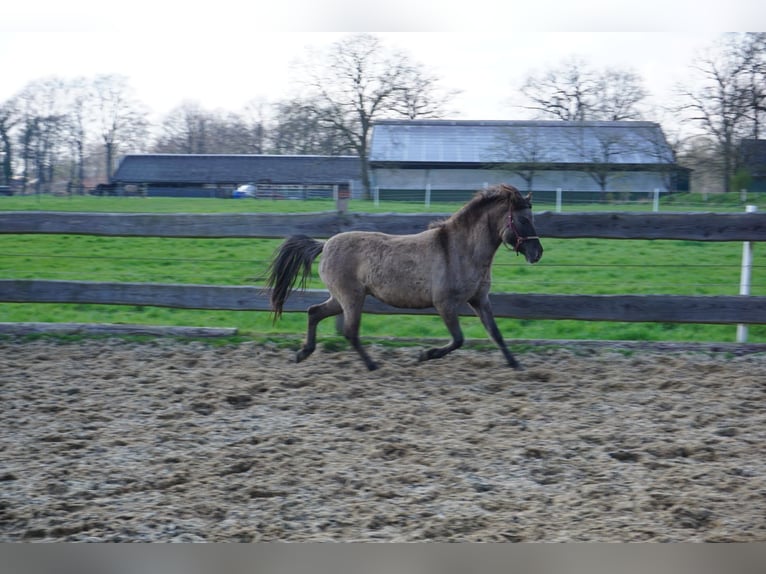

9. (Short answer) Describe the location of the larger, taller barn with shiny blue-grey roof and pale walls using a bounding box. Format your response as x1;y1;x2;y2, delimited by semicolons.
369;120;689;201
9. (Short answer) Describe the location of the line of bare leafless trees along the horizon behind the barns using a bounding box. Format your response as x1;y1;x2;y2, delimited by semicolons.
0;33;766;198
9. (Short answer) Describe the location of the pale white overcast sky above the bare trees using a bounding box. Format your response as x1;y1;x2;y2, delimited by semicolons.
0;0;766;130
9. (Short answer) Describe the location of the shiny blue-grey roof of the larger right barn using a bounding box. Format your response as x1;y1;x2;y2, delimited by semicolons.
369;120;675;166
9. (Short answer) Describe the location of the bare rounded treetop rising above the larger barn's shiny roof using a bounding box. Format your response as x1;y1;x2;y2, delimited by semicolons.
521;58;647;121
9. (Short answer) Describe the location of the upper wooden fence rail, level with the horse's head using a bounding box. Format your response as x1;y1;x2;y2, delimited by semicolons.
0;211;766;241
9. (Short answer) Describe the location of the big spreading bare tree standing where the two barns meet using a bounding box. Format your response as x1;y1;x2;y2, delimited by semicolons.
299;34;452;197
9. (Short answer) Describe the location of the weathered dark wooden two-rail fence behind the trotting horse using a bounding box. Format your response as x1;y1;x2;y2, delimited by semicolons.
0;212;766;324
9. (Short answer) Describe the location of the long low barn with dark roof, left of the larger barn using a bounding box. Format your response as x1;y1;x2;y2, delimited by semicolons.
112;154;362;199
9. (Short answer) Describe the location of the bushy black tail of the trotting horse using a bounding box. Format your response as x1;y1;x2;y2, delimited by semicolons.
266;235;324;322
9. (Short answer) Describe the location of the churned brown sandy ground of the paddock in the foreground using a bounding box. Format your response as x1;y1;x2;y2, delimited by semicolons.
0;338;766;542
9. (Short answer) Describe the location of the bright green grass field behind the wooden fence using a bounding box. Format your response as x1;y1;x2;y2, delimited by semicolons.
0;196;766;342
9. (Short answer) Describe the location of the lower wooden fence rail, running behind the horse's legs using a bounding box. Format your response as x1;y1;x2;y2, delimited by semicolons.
0;279;766;324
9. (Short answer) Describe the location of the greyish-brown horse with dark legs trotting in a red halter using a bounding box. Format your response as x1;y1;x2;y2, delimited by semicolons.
267;184;543;371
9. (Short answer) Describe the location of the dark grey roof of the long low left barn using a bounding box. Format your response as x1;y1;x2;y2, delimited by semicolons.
112;154;360;184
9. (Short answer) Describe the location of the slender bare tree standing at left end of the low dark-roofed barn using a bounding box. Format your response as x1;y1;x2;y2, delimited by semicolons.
93;75;148;183
